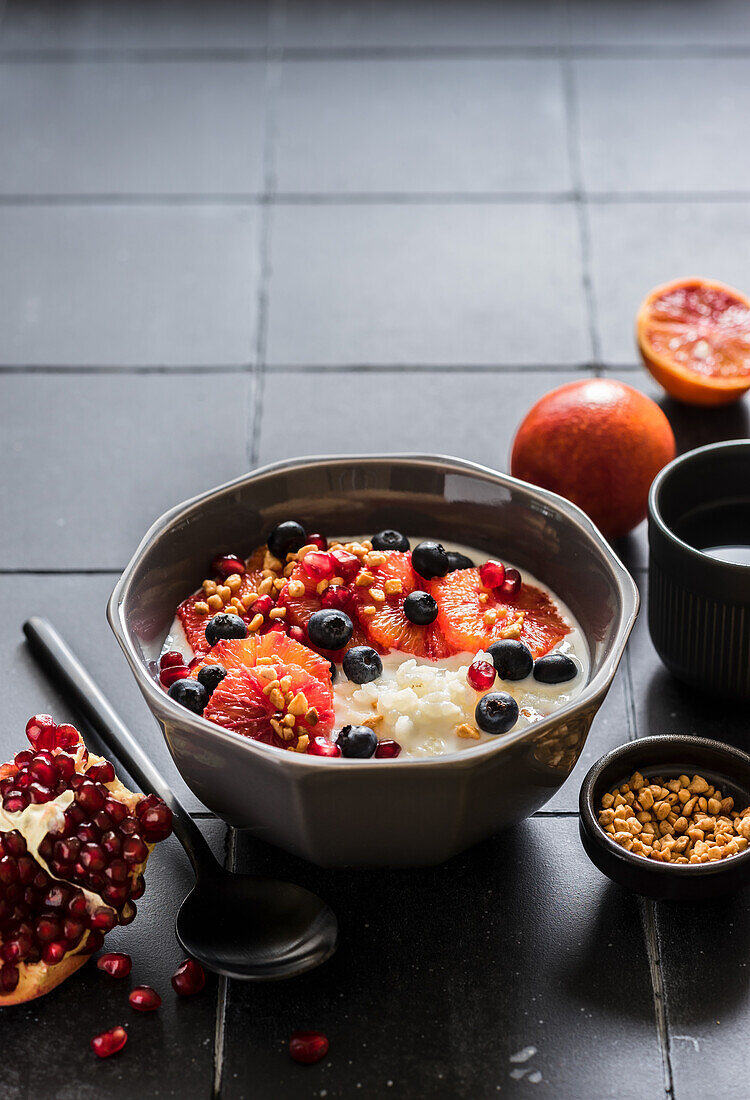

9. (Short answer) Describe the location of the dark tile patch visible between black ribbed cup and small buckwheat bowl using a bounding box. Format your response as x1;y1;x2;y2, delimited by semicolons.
629;573;750;752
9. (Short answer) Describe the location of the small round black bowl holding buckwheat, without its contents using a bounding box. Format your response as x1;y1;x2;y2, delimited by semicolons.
578;734;750;901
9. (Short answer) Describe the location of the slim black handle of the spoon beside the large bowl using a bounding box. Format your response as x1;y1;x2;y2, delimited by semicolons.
23;618;216;875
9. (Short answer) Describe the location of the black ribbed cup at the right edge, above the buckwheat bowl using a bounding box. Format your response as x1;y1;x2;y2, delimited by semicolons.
649;439;750;700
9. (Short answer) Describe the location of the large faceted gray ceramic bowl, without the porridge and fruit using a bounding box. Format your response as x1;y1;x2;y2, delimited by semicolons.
108;455;638;867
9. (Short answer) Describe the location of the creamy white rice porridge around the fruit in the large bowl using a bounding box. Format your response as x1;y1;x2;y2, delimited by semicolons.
164;536;589;759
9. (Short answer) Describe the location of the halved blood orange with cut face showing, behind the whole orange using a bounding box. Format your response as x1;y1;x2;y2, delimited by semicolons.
636;277;750;405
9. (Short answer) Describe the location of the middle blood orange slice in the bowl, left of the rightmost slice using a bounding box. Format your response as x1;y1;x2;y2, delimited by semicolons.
354;550;456;660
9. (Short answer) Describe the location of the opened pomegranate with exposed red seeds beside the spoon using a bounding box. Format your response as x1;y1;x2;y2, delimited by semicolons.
0;715;172;1005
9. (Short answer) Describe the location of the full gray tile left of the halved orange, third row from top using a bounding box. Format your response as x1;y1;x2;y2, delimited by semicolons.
268;204;591;366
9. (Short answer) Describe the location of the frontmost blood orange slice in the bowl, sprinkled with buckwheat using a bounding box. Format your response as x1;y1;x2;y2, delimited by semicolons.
203;647;334;749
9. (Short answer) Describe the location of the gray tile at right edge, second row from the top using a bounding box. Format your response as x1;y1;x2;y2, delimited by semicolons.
575;57;750;194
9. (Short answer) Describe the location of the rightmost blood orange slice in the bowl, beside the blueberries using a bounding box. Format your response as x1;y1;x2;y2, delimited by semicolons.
432;569;570;659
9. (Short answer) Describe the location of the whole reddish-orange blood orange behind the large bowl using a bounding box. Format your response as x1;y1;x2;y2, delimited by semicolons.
510;378;675;538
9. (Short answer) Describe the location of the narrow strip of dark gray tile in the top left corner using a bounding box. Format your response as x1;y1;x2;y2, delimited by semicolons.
0;0;267;52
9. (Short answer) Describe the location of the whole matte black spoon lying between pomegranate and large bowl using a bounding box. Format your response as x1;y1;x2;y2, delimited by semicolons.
23;618;339;981
